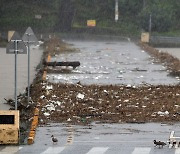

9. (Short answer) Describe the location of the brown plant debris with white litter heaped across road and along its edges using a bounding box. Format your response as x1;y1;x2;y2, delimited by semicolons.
3;36;180;144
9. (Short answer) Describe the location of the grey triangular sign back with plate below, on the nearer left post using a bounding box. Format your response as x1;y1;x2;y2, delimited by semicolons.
6;32;27;54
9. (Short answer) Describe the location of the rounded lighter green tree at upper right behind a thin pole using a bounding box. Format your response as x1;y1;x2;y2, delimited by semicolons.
139;0;175;32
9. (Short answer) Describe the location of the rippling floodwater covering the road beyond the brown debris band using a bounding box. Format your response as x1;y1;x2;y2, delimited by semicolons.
48;41;180;85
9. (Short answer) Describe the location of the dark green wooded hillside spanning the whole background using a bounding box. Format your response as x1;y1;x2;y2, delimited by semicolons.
0;0;180;33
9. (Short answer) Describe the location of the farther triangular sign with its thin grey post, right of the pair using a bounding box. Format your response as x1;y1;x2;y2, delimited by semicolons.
22;27;38;103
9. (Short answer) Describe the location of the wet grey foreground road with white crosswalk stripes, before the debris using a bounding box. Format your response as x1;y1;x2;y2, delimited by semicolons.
0;123;180;154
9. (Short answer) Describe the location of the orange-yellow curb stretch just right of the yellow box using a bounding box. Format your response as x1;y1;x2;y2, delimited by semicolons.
27;108;39;144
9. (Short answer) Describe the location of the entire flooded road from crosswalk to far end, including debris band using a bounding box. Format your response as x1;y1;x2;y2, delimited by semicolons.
0;37;180;154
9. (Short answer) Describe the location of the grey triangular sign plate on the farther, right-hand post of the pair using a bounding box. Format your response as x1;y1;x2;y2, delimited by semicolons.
22;27;39;45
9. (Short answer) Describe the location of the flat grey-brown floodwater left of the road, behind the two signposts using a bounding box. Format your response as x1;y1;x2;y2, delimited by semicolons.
0;47;42;110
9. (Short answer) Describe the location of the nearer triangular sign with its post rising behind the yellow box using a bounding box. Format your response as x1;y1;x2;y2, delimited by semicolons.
6;32;27;110
